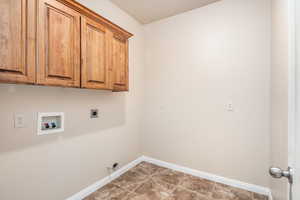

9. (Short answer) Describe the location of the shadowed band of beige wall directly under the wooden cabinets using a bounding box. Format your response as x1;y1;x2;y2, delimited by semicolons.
0;84;126;154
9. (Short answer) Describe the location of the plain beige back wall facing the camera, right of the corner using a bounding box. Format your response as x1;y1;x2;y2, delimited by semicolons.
142;0;270;186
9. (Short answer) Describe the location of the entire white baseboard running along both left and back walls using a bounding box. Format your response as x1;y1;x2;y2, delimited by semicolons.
66;156;272;200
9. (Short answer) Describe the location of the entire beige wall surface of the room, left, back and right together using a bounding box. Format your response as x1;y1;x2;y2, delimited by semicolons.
0;0;288;200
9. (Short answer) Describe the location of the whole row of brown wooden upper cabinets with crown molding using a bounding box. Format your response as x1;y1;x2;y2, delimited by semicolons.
0;0;132;91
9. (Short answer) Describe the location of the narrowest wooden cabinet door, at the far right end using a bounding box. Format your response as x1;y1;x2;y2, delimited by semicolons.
112;34;128;91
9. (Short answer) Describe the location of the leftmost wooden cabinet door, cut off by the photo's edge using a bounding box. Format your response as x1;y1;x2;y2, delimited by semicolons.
0;0;36;83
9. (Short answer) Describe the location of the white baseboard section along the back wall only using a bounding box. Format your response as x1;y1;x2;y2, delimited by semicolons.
142;156;270;196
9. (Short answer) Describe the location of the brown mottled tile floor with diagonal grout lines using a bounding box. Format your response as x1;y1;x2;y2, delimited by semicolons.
84;162;268;200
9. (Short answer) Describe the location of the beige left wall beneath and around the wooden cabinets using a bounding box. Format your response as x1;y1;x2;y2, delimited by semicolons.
0;0;144;200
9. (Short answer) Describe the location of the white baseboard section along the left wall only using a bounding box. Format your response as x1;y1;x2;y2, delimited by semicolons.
66;157;143;200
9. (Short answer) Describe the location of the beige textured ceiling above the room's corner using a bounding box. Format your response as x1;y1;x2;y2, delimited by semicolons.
111;0;220;24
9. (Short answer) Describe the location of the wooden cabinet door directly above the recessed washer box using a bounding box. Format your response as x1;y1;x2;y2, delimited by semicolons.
37;0;80;87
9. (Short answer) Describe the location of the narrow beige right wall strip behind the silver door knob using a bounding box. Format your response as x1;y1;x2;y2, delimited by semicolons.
270;0;289;200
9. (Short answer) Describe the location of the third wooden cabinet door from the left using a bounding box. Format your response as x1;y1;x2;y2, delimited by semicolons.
81;17;112;89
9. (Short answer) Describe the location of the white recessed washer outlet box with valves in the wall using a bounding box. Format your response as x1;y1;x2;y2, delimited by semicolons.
38;112;65;135
